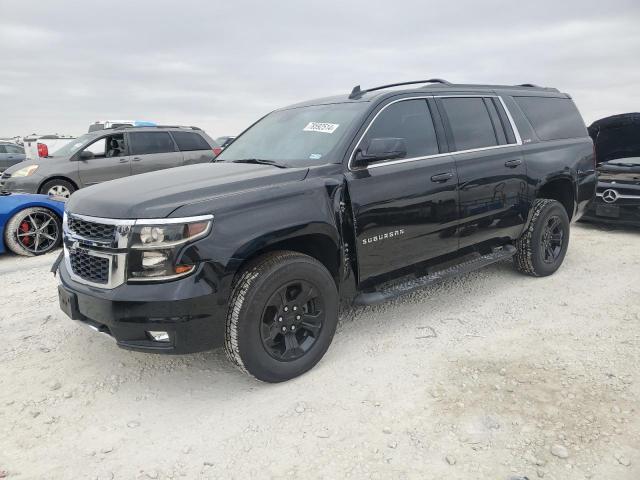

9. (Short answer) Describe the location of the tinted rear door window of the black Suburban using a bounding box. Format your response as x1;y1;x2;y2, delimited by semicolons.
442;98;498;151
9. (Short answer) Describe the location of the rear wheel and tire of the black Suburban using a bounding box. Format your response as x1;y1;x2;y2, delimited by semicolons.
514;198;570;277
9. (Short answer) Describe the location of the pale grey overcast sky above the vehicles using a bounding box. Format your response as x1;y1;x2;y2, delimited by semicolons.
0;0;640;137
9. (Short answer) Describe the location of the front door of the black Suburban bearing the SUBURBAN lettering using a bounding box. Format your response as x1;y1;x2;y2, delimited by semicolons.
347;98;458;282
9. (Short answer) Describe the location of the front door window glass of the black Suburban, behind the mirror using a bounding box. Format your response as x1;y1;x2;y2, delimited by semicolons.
361;99;439;158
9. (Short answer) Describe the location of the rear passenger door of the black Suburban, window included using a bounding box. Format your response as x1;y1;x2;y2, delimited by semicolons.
437;95;529;248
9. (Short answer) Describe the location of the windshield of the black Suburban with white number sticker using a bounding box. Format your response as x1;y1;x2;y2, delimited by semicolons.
217;102;368;167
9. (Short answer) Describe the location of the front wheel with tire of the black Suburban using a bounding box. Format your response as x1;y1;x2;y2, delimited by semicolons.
225;251;339;383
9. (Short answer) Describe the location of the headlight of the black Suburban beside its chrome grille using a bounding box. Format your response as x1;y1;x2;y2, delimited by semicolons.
128;215;213;282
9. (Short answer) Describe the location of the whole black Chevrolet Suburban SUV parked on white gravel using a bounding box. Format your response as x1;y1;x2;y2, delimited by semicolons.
59;79;596;382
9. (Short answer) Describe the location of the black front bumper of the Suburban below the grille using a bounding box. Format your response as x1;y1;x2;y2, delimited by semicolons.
58;262;228;354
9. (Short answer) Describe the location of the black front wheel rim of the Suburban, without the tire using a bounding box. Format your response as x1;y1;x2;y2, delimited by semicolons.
260;280;325;362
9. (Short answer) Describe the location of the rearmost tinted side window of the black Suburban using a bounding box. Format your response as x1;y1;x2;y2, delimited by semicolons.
514;97;587;140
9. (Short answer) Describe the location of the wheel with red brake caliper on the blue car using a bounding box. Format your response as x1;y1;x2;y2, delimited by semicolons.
4;207;62;257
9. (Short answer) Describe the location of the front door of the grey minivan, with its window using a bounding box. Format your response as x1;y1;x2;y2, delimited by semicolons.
74;137;131;187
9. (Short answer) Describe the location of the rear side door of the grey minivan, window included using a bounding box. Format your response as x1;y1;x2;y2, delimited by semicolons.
127;132;183;175
